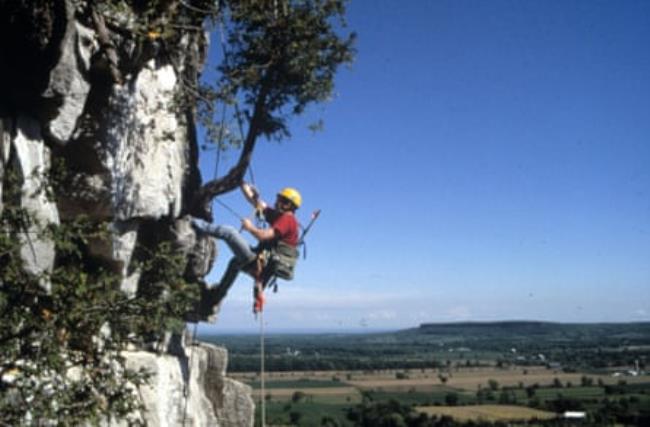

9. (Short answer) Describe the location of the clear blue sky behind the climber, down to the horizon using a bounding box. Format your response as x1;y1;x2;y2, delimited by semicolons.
195;0;650;332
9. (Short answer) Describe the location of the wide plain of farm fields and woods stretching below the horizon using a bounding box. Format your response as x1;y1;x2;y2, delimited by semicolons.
201;322;650;427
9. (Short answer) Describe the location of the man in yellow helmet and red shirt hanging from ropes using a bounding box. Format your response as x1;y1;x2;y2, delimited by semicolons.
194;183;302;306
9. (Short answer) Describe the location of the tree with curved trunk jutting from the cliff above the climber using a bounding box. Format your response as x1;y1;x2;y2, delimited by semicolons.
195;0;356;220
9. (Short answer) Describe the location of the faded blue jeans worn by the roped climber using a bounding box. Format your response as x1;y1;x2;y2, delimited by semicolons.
194;223;257;304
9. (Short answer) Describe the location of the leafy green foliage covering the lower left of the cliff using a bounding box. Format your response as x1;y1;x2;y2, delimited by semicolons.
0;166;196;425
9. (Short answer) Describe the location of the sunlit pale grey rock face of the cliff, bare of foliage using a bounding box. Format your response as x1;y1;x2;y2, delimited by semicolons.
0;0;249;426
